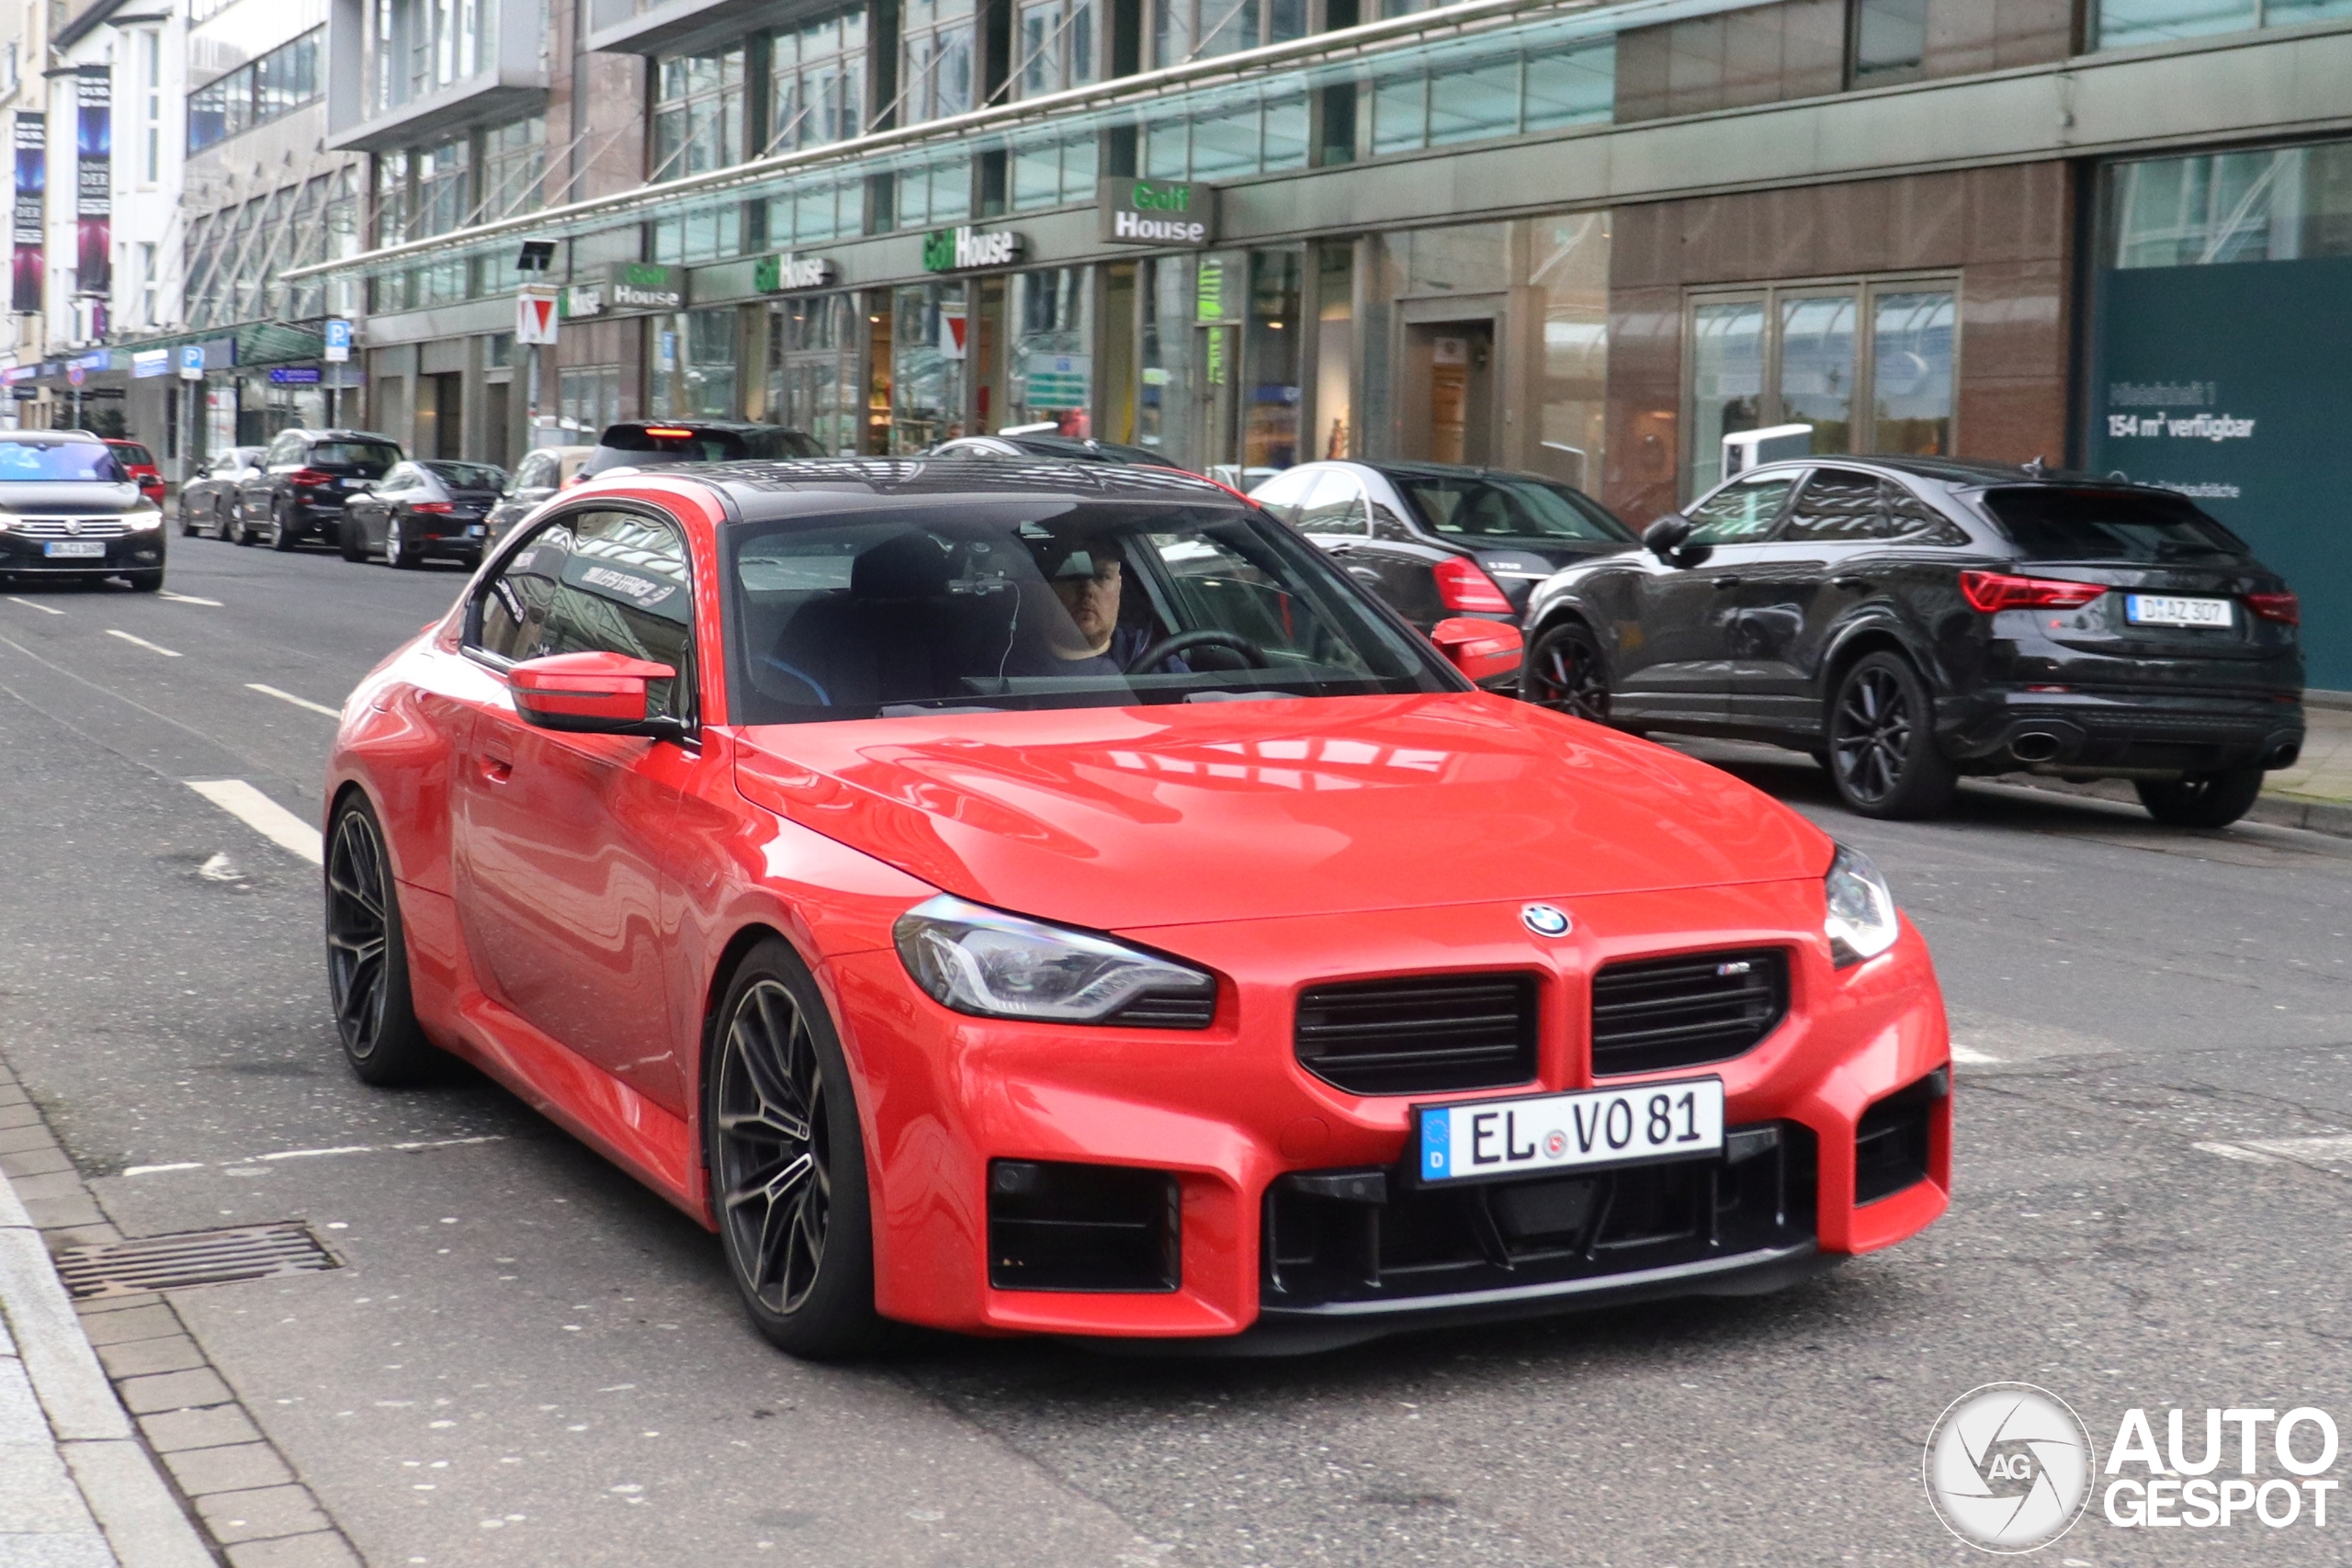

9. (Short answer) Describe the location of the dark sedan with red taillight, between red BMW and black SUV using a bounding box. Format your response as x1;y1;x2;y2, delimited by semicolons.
1251;461;1634;649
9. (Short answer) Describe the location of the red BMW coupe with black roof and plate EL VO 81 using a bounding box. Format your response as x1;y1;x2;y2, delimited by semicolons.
327;458;1952;1357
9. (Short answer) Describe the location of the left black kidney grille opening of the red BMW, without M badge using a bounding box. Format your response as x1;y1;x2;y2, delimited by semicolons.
1296;976;1536;1096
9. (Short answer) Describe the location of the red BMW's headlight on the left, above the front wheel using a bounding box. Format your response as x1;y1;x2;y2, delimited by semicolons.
891;894;1216;1027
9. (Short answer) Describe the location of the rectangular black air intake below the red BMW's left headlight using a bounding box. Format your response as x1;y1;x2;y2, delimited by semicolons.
988;1159;1183;1291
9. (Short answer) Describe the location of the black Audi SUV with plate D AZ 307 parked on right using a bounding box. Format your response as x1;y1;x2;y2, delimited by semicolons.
1520;458;2302;828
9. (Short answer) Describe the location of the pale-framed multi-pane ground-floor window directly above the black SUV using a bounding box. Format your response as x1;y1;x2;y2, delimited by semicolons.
1684;277;1959;496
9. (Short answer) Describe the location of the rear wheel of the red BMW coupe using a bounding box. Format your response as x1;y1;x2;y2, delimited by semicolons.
327;795;433;1089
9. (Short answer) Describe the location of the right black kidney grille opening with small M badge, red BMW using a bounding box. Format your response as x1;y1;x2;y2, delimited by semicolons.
1592;947;1788;1077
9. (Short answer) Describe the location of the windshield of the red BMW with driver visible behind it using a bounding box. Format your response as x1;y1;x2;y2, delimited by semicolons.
727;496;1461;724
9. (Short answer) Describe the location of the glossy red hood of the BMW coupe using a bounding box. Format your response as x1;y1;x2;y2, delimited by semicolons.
736;694;1830;929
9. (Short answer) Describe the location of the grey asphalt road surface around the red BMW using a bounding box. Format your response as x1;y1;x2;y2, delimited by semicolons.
0;538;2352;1568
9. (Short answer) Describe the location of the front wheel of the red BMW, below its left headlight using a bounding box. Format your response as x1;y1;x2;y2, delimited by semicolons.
703;941;889;1361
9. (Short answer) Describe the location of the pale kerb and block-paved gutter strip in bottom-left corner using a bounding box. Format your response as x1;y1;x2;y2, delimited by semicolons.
0;1058;360;1568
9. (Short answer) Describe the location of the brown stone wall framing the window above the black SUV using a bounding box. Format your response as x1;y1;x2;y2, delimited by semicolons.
1601;163;2075;525
